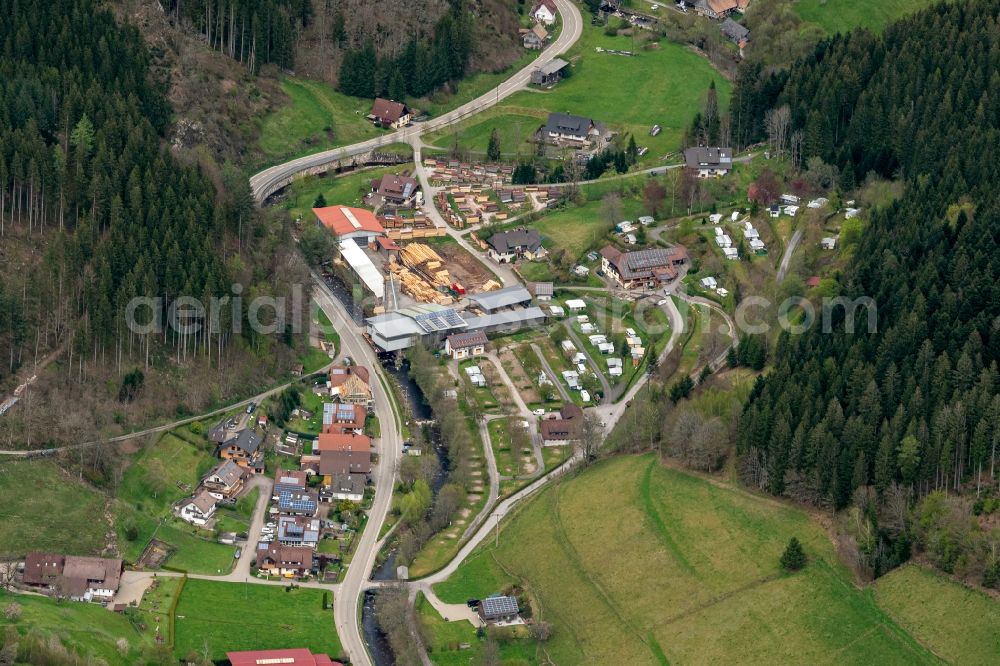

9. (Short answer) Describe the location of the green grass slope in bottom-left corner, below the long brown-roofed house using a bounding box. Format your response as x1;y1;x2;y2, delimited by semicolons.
0;591;151;666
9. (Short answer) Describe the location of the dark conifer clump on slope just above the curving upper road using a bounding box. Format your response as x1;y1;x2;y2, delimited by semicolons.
340;0;475;99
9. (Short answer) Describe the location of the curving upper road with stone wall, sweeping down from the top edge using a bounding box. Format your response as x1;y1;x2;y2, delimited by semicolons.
250;0;583;203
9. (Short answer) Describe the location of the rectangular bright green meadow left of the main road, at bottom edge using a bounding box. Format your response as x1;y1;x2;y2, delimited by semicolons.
174;579;341;660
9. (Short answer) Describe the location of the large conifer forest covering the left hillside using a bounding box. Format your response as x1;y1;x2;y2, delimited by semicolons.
0;0;300;404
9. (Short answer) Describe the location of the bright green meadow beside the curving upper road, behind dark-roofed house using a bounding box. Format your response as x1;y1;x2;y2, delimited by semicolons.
427;26;730;162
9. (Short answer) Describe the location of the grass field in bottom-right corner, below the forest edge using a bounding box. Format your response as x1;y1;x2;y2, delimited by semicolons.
875;565;1000;666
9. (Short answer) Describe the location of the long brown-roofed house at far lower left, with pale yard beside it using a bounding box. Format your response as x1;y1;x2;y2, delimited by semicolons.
22;552;122;601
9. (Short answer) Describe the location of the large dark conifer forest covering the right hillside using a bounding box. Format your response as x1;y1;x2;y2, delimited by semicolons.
733;0;1000;570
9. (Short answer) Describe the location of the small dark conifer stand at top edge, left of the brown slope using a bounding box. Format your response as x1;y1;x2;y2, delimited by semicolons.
164;0;312;72
